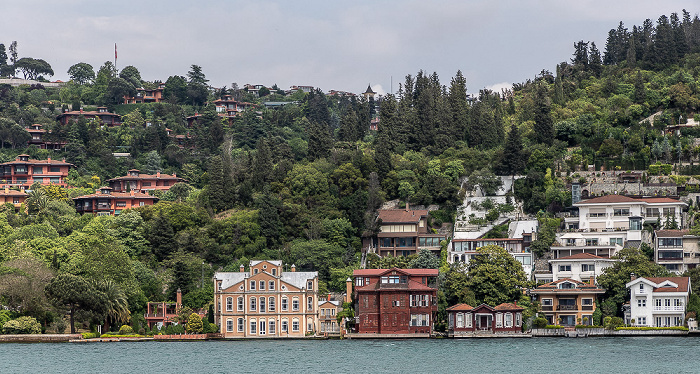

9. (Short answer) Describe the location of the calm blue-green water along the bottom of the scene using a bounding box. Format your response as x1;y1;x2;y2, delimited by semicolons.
0;337;700;374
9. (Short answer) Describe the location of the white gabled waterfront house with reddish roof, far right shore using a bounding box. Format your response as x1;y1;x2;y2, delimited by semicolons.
626;274;690;327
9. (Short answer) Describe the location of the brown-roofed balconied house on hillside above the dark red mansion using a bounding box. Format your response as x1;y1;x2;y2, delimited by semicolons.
367;209;446;257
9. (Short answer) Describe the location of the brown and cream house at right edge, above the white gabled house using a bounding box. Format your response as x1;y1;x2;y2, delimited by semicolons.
654;230;700;274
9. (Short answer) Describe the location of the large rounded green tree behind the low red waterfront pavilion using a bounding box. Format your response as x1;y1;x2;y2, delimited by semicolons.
467;245;527;305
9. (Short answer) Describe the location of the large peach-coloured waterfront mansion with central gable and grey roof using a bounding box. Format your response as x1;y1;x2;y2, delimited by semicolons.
214;260;319;338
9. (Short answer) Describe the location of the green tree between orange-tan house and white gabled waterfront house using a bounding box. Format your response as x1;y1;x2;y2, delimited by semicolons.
598;248;669;311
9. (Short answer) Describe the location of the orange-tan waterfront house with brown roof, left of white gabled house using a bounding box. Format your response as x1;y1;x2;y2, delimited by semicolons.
530;278;605;326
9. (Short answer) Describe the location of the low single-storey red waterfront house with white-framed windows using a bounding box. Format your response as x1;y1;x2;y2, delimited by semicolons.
447;303;525;337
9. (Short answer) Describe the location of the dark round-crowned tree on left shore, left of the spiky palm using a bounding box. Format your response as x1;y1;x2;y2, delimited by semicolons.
46;273;96;334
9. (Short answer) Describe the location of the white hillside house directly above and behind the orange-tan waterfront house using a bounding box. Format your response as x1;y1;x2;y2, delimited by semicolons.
549;253;616;282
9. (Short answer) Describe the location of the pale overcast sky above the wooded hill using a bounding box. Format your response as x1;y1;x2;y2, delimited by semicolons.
0;0;700;93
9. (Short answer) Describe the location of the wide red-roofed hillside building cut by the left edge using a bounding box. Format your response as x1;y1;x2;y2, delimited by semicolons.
0;155;73;190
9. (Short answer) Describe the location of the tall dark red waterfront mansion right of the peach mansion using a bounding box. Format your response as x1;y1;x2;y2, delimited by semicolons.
353;268;438;335
